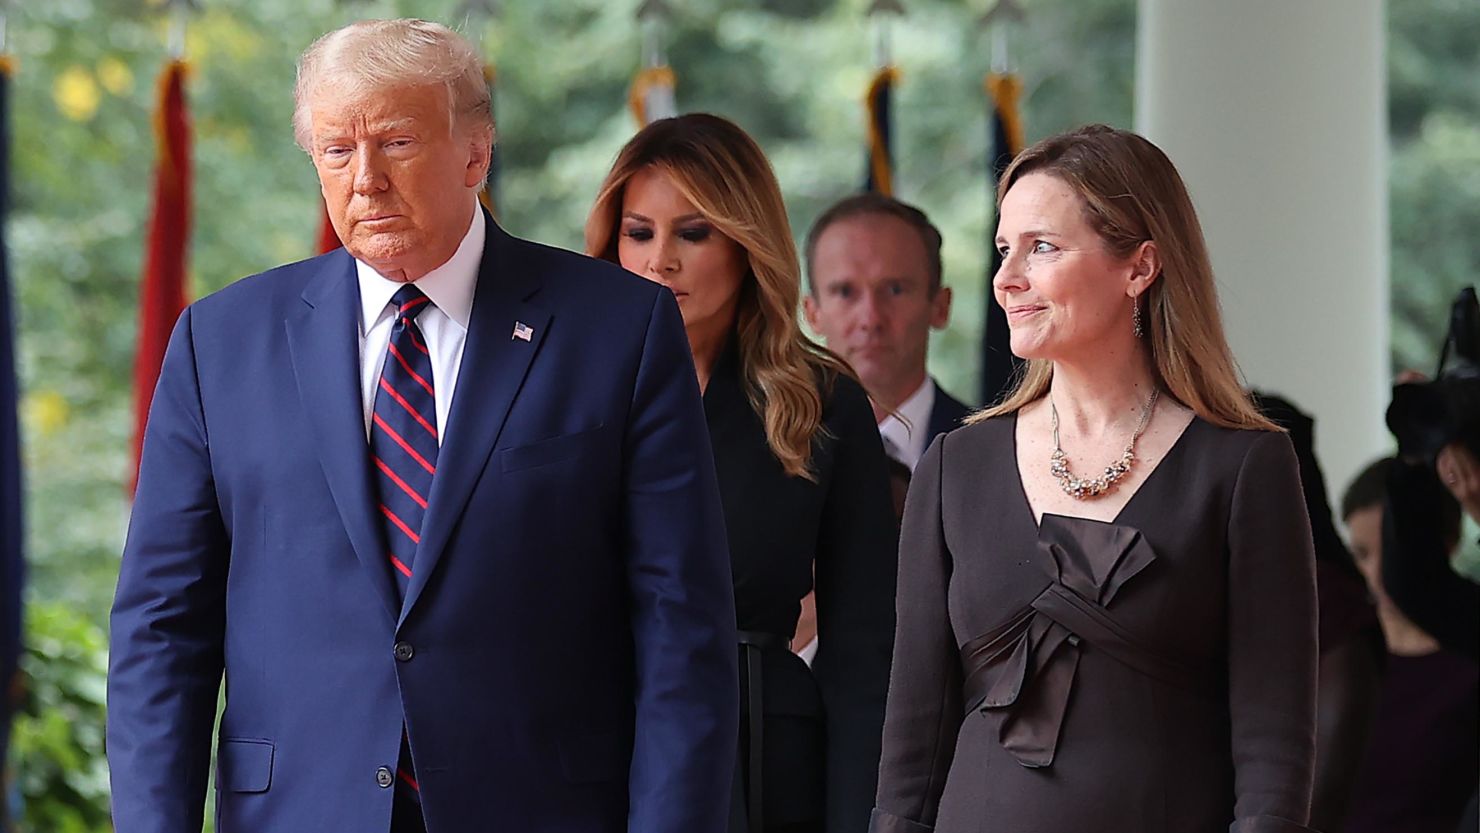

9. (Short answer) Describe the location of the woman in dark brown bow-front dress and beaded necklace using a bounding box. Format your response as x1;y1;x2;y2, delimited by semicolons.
872;126;1316;833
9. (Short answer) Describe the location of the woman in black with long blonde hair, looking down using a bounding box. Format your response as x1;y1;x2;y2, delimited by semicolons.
586;114;897;833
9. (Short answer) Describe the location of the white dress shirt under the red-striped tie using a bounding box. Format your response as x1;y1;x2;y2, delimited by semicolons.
355;209;487;444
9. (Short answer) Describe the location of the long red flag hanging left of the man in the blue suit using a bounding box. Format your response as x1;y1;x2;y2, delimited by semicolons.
133;59;191;481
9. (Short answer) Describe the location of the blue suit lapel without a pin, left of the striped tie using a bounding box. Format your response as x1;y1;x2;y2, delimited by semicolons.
284;250;400;618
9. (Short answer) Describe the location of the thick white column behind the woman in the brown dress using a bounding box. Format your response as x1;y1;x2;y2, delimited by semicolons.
1135;0;1391;494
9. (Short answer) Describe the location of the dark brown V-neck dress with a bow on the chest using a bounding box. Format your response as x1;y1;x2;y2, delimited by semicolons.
872;417;1316;833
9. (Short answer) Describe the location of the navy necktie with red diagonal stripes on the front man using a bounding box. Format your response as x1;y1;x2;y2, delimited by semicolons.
370;284;438;802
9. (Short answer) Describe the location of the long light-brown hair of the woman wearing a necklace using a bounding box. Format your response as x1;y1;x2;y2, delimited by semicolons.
969;124;1280;431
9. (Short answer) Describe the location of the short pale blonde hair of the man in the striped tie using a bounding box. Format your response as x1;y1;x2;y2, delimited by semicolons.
293;18;493;152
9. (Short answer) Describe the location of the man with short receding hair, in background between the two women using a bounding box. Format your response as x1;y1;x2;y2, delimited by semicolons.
802;194;971;469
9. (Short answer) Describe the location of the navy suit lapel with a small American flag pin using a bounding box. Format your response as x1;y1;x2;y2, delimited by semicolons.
401;213;551;621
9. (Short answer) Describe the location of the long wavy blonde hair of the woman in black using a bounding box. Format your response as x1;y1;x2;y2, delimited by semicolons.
586;114;854;479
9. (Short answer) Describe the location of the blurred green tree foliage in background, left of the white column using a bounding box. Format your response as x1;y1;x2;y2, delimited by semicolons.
2;0;1135;621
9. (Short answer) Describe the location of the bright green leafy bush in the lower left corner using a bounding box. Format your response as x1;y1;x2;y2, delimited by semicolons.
10;602;112;833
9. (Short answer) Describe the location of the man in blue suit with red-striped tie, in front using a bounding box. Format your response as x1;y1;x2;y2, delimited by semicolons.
108;21;739;833
